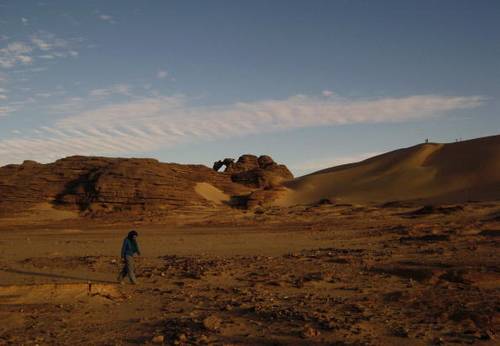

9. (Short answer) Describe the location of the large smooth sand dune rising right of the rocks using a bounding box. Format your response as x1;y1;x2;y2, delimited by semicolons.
275;136;500;206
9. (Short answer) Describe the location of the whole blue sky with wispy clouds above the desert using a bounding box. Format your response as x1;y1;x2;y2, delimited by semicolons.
0;0;500;175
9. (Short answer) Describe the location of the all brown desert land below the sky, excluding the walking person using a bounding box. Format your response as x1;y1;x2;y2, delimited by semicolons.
0;132;500;345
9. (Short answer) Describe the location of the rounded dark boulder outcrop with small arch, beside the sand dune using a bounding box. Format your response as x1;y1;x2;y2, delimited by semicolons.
214;154;293;188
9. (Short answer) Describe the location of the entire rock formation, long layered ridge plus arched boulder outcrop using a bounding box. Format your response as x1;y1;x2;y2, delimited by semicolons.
0;155;293;217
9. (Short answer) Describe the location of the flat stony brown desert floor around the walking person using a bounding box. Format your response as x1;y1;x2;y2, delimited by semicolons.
0;203;500;345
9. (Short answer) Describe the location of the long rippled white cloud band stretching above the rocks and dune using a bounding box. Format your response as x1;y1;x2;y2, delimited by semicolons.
0;95;484;163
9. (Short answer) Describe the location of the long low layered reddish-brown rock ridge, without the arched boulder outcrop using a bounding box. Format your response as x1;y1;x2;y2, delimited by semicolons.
0;156;250;215
